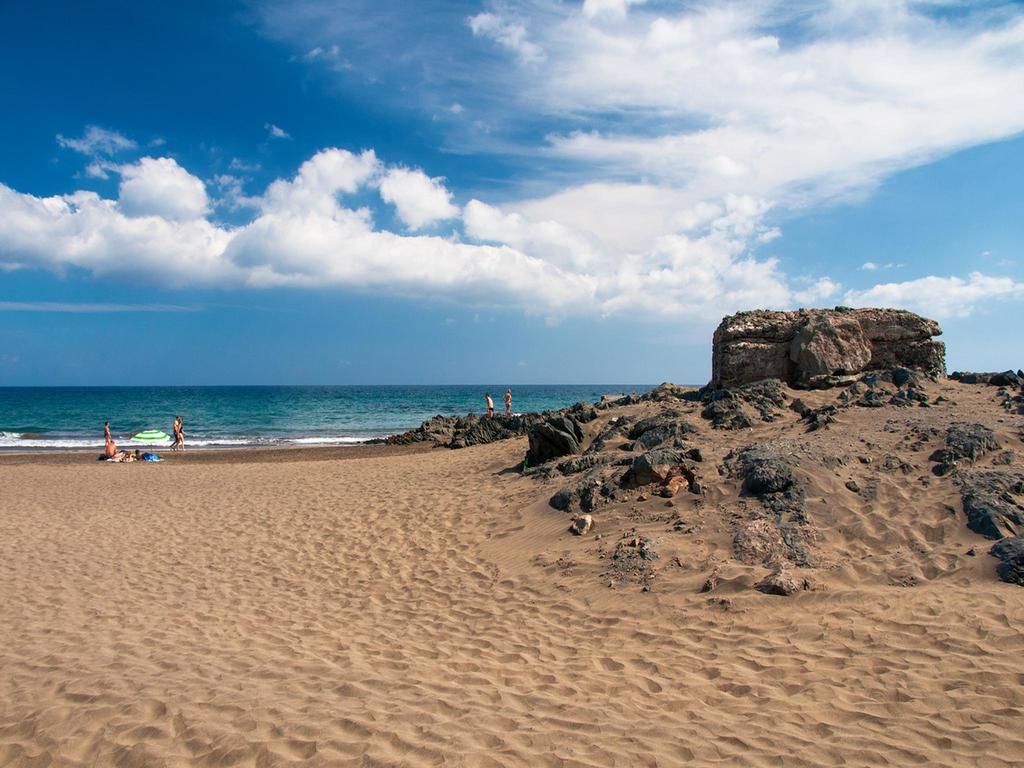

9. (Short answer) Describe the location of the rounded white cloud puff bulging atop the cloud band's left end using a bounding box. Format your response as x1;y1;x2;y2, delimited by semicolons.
118;158;210;221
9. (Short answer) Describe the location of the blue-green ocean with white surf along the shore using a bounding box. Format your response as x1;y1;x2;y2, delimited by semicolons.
0;384;651;451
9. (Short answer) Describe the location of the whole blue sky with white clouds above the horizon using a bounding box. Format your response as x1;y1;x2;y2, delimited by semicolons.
0;0;1024;386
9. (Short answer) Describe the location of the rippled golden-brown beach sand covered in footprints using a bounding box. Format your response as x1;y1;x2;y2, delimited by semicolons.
0;387;1024;766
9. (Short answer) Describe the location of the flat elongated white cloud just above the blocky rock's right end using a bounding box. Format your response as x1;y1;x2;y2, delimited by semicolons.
843;272;1024;318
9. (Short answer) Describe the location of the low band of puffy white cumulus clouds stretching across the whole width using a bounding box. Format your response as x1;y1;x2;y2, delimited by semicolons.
0;143;1024;323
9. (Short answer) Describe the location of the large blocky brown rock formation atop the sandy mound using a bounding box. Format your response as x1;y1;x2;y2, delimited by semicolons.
712;307;945;389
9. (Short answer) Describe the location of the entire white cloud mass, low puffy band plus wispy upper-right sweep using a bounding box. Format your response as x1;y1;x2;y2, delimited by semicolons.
6;0;1024;321
